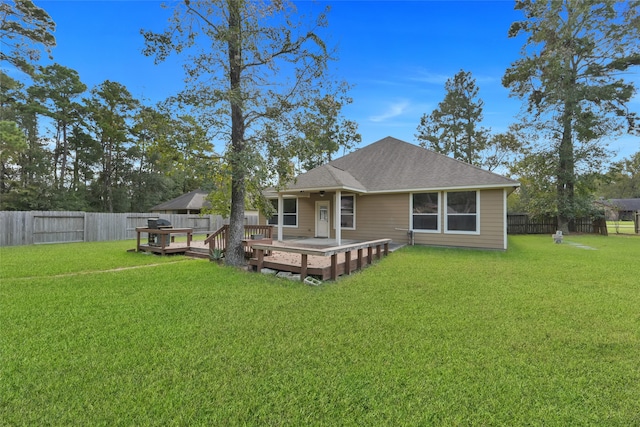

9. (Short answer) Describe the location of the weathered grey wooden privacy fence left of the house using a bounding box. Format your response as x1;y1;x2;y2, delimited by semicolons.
0;211;258;246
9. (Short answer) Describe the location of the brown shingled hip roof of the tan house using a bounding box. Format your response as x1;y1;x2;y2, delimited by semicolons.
286;137;520;193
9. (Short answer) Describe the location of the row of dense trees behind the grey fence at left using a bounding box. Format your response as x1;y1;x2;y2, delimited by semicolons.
0;64;217;212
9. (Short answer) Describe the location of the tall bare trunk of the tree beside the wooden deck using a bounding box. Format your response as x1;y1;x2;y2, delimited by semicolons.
225;1;245;266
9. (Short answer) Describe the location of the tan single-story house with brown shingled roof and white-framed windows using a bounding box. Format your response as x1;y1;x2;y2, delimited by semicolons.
260;137;520;250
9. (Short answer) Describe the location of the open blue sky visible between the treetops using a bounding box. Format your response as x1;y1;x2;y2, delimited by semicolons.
30;0;640;160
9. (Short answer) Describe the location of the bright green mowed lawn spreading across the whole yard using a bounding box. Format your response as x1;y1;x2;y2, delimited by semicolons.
0;236;640;426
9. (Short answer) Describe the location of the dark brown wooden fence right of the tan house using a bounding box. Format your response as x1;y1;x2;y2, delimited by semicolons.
507;214;607;236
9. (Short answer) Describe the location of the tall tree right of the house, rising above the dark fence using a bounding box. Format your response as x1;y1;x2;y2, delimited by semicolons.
502;0;640;231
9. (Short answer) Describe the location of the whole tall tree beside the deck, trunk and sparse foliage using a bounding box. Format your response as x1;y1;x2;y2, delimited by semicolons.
143;0;356;265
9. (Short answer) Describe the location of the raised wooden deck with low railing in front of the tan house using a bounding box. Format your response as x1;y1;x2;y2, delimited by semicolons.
249;239;391;280
